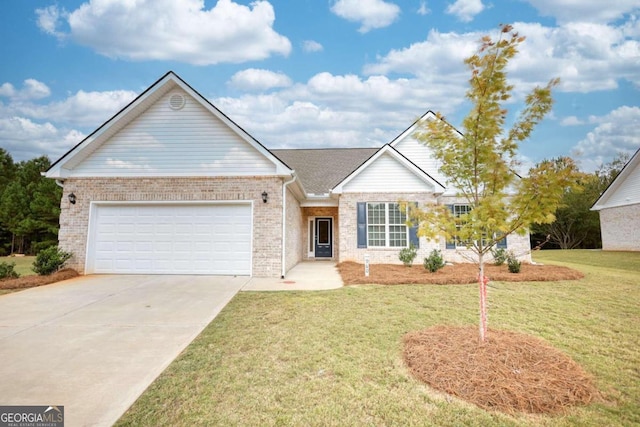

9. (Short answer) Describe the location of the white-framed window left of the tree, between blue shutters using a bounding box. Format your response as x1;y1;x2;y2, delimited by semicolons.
367;203;409;248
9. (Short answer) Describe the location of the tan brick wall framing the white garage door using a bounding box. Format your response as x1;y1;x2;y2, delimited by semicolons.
58;177;284;277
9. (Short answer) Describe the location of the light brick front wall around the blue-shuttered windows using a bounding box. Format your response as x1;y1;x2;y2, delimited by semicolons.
338;193;531;264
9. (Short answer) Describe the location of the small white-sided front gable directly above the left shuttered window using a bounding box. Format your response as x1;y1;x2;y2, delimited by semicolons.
343;153;434;193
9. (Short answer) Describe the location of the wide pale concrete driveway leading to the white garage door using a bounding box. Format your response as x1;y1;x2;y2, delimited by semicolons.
0;276;249;427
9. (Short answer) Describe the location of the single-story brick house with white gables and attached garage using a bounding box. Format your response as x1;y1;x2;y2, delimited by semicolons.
46;72;529;277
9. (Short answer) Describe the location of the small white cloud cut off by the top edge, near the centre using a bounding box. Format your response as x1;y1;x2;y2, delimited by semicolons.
331;0;400;33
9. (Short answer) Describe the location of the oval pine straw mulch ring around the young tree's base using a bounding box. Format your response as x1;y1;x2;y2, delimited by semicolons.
403;326;601;414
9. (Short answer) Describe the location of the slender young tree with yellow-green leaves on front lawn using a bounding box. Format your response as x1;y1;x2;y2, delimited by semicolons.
410;25;576;341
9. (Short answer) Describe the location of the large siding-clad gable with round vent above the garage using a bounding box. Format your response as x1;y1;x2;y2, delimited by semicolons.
46;72;292;178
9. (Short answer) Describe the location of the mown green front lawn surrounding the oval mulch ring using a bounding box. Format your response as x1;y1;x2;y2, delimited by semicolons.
117;251;640;426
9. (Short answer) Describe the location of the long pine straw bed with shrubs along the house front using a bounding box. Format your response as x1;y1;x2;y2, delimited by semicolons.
338;261;584;285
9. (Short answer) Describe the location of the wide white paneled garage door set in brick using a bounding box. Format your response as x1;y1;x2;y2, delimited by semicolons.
87;204;251;275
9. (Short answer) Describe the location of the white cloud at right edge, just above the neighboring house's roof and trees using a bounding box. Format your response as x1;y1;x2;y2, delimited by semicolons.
573;106;640;171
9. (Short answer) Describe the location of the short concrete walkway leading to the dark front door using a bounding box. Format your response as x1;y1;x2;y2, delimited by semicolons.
242;261;343;291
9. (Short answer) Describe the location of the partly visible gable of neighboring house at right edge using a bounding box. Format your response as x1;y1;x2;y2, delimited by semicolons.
591;149;640;211
